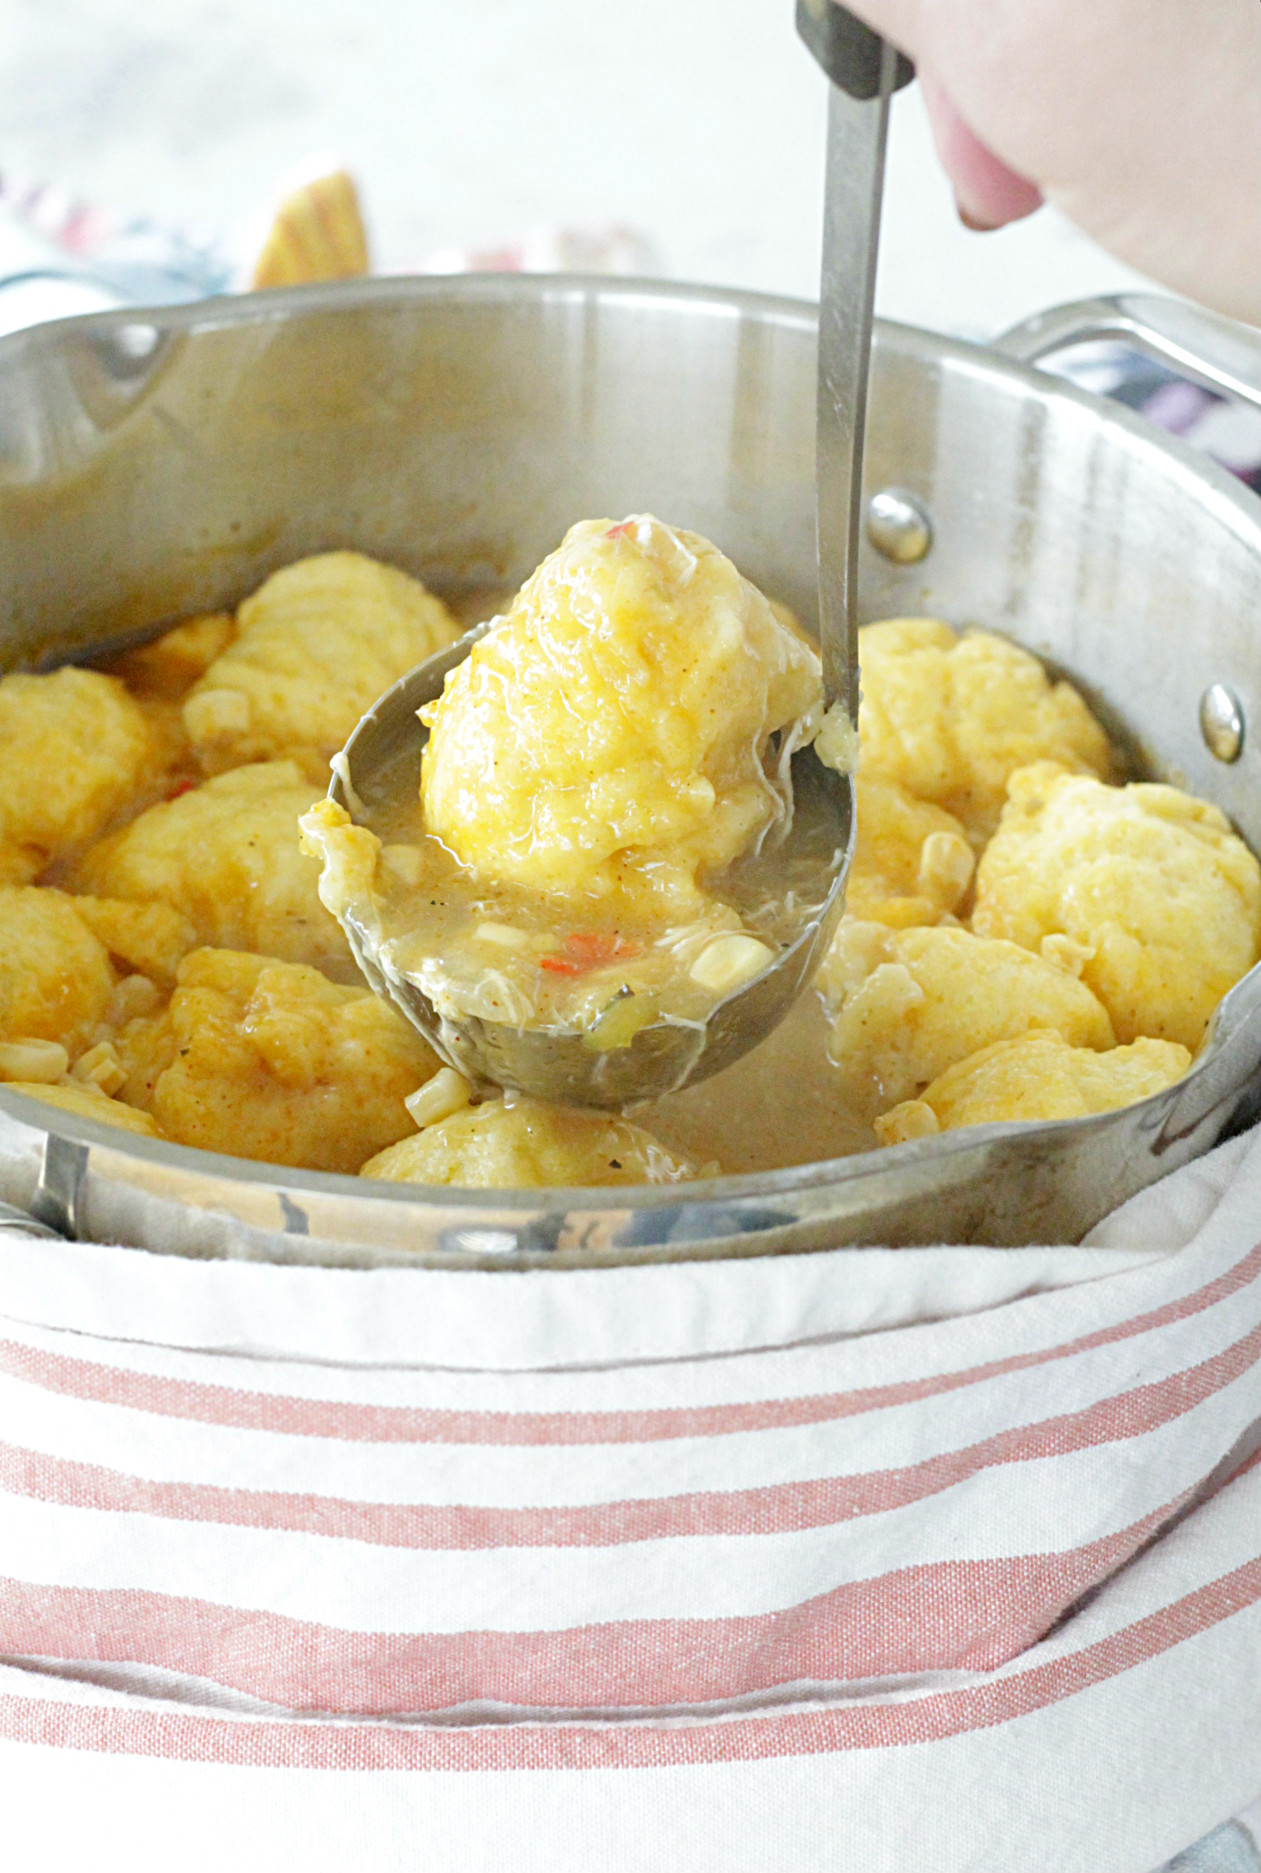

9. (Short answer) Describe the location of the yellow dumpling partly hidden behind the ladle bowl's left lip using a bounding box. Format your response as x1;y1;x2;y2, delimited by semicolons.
73;760;352;974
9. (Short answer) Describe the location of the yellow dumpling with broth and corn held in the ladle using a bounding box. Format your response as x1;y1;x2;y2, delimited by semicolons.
304;515;836;1051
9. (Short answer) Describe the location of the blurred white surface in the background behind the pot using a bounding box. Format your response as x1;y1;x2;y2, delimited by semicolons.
0;0;1161;335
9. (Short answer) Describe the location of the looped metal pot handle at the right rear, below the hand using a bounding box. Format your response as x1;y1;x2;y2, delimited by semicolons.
993;292;1261;410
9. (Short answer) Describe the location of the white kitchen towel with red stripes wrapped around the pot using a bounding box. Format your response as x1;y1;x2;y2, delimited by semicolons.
0;1133;1261;1873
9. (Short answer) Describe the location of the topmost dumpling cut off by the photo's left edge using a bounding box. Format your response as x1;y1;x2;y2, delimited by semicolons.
0;669;157;869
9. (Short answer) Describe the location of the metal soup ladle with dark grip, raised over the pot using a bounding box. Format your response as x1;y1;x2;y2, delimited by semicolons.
328;0;909;1107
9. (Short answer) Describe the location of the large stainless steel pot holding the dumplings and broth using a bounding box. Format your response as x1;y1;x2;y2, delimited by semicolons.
0;277;1261;1268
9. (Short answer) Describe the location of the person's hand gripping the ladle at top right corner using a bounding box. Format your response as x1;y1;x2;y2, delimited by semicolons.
831;0;1261;322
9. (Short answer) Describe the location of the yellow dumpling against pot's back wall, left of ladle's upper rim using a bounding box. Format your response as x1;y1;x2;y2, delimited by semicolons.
184;553;459;772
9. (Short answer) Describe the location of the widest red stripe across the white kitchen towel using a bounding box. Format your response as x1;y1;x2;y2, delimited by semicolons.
0;1498;1180;1716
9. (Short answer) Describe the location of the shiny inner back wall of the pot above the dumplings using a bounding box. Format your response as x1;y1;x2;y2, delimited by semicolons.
0;279;1261;845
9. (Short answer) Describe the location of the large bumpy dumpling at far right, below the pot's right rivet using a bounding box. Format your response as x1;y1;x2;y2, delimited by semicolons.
972;762;1261;1049
